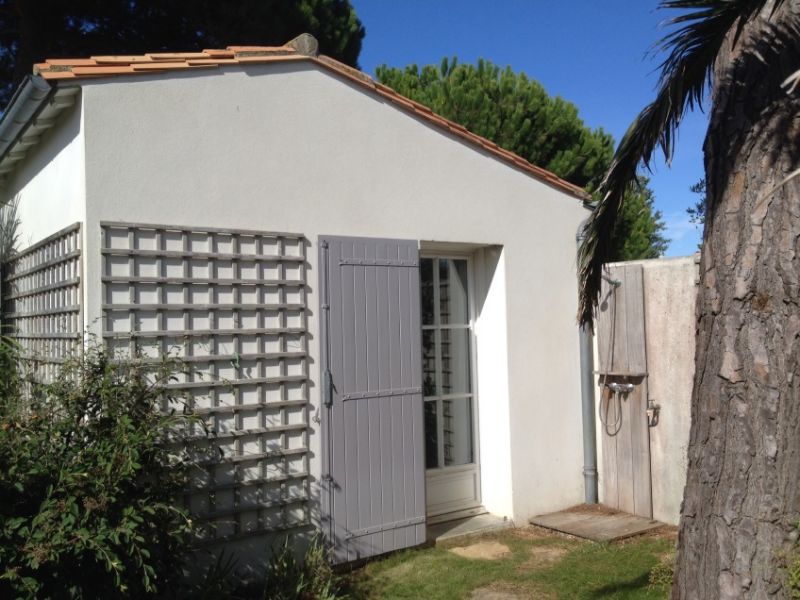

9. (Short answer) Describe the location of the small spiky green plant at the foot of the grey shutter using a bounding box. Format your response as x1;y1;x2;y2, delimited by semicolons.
263;536;346;600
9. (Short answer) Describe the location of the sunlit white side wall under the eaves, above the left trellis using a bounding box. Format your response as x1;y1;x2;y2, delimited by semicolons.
3;96;86;250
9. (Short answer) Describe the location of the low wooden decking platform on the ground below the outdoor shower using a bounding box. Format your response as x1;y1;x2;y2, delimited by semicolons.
530;506;664;542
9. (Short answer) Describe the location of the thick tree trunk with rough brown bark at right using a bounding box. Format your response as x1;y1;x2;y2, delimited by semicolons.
672;0;800;599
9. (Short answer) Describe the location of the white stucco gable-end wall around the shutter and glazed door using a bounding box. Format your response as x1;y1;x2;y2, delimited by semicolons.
70;64;587;523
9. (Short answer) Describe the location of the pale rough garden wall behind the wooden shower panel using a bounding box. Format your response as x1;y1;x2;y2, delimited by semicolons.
595;256;697;525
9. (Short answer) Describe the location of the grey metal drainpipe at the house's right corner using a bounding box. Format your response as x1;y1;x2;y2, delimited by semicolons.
575;221;597;504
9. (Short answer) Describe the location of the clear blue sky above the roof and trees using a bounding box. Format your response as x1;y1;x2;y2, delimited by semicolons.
351;0;707;256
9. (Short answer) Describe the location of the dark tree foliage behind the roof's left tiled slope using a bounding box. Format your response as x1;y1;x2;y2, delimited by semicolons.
0;0;364;106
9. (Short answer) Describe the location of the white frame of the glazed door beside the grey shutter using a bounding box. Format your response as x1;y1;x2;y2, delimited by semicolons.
419;251;485;523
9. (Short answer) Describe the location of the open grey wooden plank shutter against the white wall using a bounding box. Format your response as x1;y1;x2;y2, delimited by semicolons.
320;236;425;562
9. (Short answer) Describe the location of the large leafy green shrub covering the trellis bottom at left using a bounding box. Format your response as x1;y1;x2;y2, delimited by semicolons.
0;343;198;598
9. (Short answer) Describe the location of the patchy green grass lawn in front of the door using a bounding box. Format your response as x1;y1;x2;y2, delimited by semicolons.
351;528;675;600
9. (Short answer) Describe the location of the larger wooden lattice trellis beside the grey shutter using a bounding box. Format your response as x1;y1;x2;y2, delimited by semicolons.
102;223;310;542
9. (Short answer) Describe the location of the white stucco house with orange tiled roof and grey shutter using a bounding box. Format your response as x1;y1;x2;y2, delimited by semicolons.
0;36;588;560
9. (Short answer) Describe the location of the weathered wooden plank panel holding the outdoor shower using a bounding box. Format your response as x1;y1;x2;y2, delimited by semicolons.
597;265;653;517
